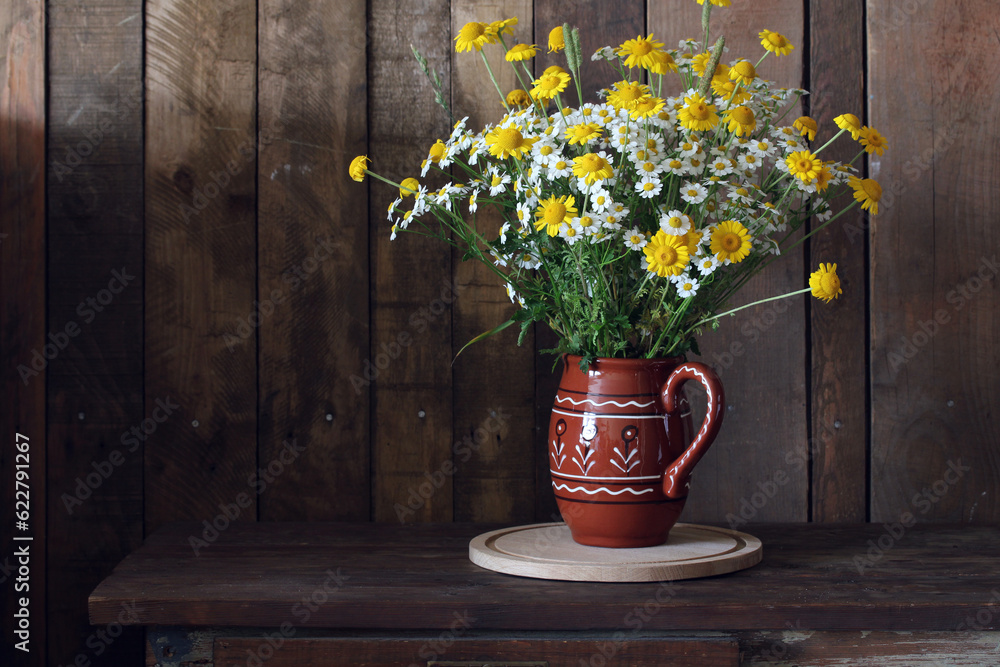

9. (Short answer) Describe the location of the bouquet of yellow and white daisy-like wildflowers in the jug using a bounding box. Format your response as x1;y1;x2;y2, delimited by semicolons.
350;0;887;363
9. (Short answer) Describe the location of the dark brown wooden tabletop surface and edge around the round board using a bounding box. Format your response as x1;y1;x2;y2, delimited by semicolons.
90;523;1000;631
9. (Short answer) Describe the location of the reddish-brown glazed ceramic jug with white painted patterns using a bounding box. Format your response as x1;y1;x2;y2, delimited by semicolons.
549;355;725;548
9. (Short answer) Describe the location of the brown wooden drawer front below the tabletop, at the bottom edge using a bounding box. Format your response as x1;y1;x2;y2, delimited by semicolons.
214;636;739;667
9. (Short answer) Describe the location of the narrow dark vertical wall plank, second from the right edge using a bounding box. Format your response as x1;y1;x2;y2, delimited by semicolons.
807;0;868;522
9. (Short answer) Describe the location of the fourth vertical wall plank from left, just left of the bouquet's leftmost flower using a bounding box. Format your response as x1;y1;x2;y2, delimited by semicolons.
256;0;370;520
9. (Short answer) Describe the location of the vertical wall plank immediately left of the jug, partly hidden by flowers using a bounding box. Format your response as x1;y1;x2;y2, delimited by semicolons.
452;0;535;522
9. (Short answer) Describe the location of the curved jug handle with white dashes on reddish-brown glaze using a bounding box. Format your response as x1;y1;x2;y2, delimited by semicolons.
660;361;726;499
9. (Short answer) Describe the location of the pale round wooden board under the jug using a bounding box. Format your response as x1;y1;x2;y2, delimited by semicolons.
469;523;763;581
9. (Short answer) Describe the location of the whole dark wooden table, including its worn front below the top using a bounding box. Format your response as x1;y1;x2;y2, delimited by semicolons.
90;523;1000;667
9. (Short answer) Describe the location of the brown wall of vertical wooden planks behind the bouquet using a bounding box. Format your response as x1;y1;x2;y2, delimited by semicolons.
0;0;1000;665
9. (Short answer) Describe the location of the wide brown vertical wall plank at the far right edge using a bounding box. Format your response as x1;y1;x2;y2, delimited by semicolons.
868;0;1000;522
